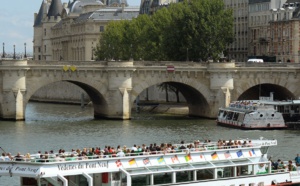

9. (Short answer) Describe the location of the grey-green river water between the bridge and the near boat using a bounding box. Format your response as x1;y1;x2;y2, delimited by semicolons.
0;103;300;186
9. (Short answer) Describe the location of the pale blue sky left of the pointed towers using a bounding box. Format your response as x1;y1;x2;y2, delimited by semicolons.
0;0;141;53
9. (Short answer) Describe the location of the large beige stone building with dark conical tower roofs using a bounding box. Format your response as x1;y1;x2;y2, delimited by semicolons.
33;0;139;61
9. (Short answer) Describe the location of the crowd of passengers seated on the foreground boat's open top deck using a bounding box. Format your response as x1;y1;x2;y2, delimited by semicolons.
0;140;252;162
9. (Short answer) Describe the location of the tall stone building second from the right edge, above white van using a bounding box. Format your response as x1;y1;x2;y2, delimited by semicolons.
248;0;284;59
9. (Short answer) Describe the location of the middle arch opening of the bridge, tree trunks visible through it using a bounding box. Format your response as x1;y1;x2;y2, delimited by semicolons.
133;81;210;118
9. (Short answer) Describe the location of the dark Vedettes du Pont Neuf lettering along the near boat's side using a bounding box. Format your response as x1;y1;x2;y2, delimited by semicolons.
57;162;107;171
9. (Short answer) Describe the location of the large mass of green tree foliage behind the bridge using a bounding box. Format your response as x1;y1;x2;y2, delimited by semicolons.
96;0;233;61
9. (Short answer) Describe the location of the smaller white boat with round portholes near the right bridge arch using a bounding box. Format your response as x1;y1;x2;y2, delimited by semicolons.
217;101;287;130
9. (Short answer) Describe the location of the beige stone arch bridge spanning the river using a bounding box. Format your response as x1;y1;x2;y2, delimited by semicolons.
0;59;300;120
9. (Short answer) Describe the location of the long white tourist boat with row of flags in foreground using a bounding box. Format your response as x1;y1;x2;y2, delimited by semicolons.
0;138;300;186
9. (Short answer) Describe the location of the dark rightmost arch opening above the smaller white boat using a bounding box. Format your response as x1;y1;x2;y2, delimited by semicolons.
238;83;296;100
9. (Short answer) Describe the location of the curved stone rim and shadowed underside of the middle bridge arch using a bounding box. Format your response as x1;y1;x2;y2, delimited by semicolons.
131;78;211;117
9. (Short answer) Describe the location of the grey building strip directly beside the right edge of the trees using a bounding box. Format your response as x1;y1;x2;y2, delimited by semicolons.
223;0;249;62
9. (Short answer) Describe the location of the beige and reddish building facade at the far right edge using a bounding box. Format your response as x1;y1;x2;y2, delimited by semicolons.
269;0;300;63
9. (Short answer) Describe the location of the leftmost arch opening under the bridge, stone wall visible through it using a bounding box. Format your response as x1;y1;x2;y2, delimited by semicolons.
25;81;108;119
